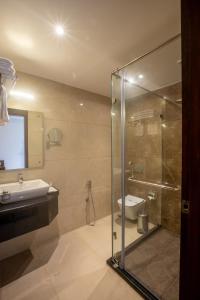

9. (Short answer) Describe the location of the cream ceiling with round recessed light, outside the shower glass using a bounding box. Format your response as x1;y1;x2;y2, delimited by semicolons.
0;0;180;96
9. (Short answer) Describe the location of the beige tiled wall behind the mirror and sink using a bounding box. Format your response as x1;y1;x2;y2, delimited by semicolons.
0;73;111;259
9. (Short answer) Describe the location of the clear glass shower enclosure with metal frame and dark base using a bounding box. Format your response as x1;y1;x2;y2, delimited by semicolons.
108;35;182;300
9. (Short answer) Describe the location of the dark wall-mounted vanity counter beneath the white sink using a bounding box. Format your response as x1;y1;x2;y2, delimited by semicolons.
0;191;59;242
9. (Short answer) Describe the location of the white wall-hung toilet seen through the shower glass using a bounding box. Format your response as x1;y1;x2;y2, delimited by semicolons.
117;195;145;220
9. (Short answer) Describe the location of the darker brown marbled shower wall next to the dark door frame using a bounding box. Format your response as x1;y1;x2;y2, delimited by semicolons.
161;83;182;234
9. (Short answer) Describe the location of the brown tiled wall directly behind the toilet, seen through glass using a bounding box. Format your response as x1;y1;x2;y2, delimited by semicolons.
125;93;163;224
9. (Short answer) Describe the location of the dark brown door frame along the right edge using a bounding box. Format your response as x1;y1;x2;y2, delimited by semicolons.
180;0;200;300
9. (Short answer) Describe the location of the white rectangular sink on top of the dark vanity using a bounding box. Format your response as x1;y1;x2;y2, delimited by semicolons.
0;179;49;204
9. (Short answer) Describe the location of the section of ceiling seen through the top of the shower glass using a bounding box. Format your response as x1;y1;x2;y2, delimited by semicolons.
112;35;182;100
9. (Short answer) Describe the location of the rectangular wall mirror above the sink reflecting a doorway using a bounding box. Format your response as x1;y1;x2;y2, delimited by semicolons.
0;108;44;171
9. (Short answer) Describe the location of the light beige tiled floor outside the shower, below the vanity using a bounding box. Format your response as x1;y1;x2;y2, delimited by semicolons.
0;217;142;300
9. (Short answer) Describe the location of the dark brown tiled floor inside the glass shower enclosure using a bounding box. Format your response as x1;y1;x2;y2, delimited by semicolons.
125;228;180;300
